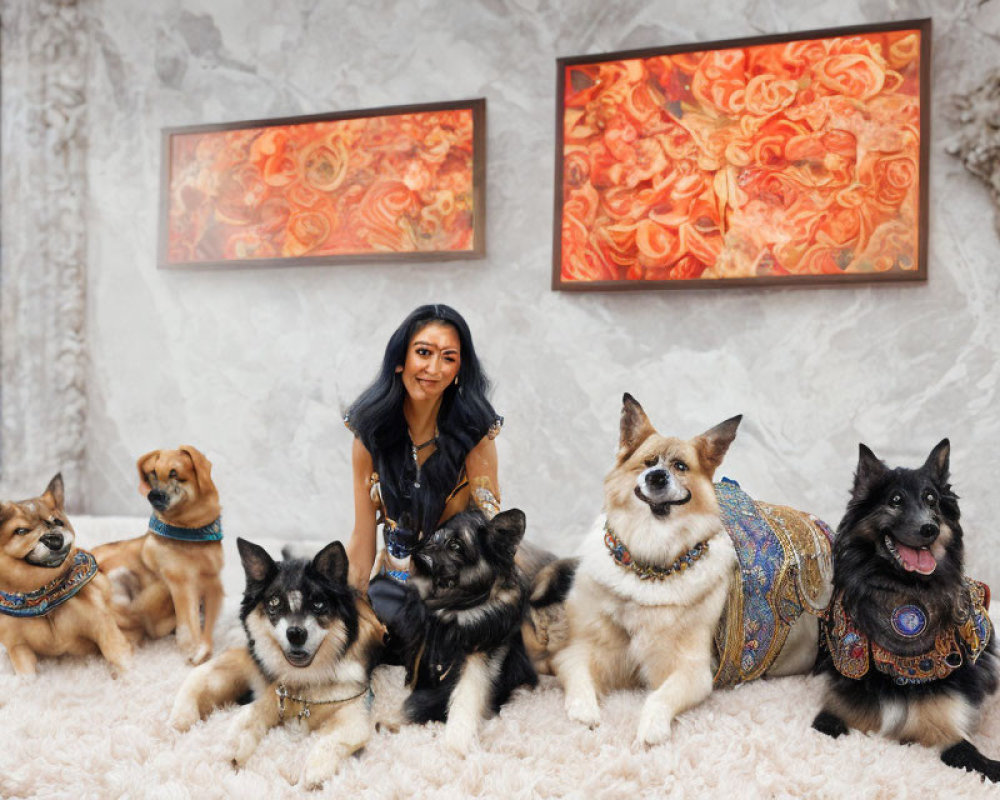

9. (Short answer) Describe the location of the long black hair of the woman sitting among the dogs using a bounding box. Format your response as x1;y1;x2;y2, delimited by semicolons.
346;304;499;533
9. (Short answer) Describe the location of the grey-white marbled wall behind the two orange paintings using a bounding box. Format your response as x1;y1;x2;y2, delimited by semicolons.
74;0;1000;583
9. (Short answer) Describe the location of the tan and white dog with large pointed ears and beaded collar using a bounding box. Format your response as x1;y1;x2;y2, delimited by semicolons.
532;394;817;745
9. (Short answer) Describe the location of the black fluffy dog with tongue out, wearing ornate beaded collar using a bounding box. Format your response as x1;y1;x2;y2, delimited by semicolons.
813;439;1000;781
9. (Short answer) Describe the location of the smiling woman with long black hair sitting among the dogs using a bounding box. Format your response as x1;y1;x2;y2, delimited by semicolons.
344;305;503;629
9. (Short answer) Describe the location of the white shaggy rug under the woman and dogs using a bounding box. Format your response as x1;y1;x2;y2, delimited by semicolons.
0;518;1000;800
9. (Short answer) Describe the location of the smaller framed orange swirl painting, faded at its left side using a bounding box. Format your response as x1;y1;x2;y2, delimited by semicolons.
159;99;486;267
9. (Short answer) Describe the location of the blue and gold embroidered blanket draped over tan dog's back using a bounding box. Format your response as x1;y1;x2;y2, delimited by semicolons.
715;478;833;686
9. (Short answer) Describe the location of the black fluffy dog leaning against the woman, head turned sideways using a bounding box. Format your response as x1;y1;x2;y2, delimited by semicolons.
398;509;538;754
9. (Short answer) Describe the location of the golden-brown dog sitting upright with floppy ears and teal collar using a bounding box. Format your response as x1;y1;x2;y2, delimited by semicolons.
94;445;223;664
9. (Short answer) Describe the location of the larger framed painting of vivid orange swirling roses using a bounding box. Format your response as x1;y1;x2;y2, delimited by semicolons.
552;19;931;290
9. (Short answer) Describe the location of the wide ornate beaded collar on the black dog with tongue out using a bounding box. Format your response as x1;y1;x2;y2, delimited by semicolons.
826;578;993;686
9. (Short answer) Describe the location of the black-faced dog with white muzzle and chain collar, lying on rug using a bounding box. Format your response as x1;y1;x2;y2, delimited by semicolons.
170;539;385;788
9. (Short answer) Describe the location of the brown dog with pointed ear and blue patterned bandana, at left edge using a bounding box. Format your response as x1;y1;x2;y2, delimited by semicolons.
0;475;132;675
